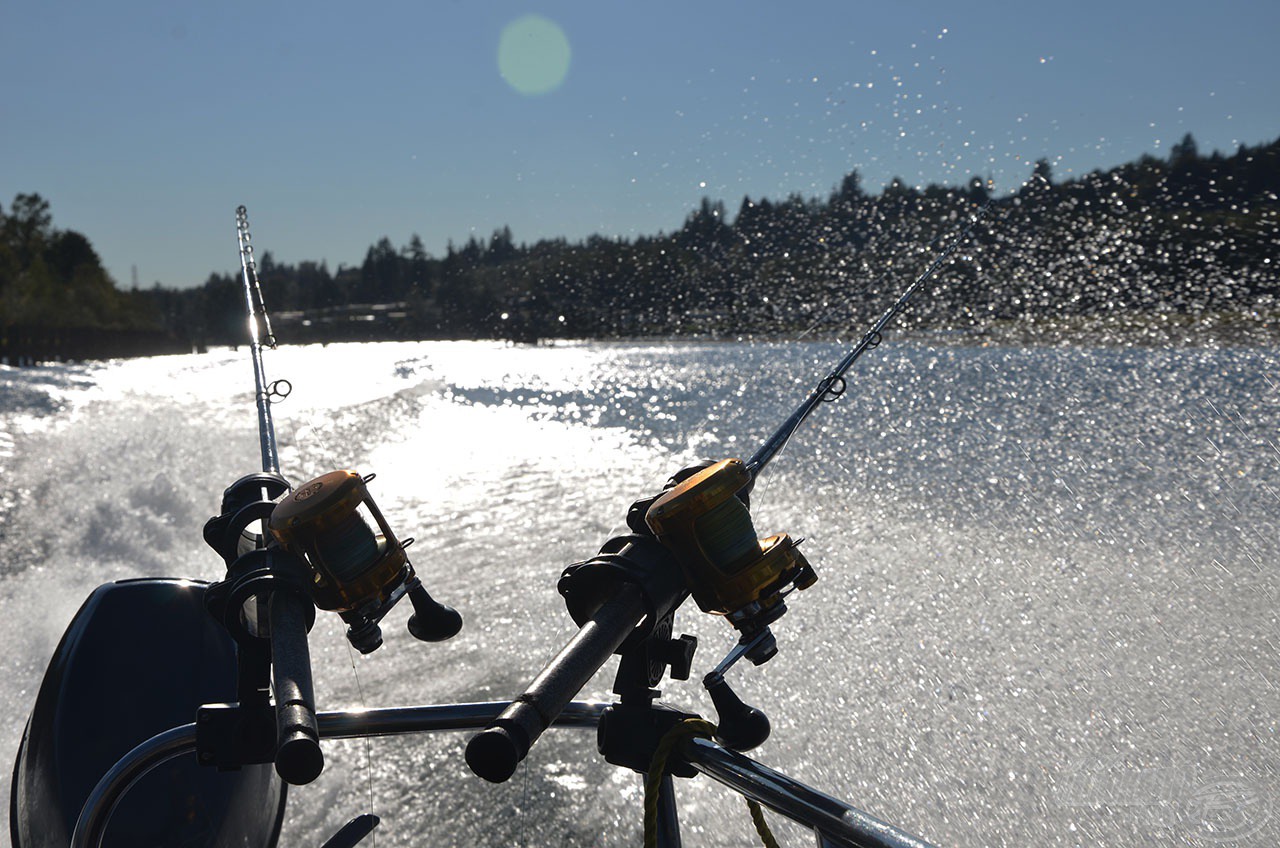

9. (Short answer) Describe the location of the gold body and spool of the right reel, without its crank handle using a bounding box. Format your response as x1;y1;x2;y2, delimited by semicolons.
645;459;818;626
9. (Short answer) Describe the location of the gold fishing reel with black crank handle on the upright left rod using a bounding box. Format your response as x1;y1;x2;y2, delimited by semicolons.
268;470;462;653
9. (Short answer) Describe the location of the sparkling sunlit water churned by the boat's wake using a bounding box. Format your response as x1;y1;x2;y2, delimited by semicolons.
0;339;1280;847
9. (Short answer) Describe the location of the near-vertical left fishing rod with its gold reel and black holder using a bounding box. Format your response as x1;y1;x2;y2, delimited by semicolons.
204;206;462;784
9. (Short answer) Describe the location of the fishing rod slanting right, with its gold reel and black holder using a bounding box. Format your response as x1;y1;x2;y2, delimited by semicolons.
467;201;991;783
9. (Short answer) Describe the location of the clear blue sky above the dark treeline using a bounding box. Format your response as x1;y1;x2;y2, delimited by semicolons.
0;0;1280;287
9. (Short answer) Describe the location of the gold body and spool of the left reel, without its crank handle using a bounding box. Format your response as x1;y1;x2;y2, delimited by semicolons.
268;470;410;612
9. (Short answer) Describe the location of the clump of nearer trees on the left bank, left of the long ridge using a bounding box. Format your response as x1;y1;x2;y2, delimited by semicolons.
0;193;182;361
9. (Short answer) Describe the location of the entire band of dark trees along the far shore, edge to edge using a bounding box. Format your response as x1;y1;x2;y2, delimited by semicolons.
0;135;1280;364
